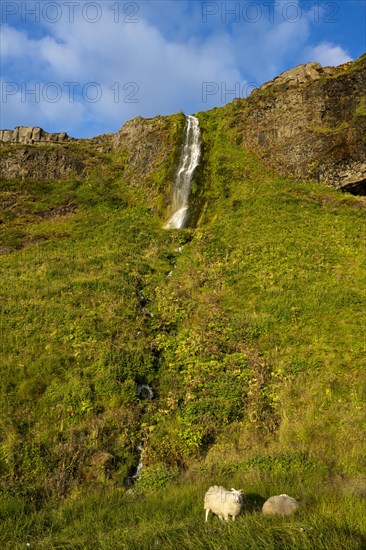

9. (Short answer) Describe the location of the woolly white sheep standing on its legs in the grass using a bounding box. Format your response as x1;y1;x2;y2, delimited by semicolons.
204;485;243;521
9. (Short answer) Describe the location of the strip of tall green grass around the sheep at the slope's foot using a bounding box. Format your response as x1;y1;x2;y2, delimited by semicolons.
0;470;366;550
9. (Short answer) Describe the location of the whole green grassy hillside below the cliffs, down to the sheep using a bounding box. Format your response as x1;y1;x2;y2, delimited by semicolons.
0;102;365;549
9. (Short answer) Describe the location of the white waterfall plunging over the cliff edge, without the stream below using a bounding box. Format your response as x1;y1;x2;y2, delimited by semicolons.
165;115;201;229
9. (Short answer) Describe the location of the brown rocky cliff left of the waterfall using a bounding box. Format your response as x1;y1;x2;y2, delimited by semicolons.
0;114;185;185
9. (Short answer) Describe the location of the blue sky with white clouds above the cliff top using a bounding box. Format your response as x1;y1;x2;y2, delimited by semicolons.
0;0;366;137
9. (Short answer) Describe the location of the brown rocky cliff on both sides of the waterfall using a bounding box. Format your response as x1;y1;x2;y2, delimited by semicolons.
0;55;366;194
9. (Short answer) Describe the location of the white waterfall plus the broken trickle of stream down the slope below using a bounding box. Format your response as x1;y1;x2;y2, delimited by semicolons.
129;115;201;482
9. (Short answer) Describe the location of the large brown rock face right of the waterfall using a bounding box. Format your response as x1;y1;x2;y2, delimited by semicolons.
234;56;366;194
